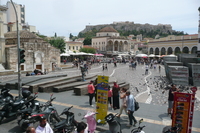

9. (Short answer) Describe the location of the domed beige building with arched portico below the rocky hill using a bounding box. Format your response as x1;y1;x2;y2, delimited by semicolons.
92;27;138;55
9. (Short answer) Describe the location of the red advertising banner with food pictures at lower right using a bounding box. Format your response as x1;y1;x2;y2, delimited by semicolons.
172;92;193;133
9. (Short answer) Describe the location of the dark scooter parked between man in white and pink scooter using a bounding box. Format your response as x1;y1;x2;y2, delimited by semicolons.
53;106;77;133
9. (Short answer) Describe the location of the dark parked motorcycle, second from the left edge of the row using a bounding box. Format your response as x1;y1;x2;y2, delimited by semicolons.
17;93;42;131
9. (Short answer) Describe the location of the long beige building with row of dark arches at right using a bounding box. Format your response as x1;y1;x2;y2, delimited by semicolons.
148;34;198;55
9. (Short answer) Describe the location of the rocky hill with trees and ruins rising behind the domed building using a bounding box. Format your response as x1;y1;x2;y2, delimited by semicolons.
79;21;184;38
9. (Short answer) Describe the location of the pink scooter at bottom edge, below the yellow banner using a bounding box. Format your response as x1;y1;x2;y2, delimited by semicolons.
84;111;97;133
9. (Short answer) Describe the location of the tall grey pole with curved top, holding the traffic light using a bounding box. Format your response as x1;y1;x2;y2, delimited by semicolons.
10;0;22;98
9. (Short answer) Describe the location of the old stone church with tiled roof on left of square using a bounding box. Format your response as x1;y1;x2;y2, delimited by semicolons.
4;30;60;72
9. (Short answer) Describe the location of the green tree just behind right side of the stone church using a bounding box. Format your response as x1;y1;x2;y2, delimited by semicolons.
49;37;65;54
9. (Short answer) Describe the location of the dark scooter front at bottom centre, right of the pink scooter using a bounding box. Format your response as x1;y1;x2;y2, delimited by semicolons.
105;113;122;133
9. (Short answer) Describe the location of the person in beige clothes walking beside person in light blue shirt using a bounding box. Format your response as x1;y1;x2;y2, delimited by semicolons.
117;88;127;117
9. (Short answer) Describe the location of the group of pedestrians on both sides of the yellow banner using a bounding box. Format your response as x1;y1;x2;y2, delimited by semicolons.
88;79;137;127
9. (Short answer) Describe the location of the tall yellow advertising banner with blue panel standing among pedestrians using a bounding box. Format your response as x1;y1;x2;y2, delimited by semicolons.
96;76;109;124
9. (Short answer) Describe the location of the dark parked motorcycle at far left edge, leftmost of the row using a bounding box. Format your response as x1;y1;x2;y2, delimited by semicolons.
0;90;33;123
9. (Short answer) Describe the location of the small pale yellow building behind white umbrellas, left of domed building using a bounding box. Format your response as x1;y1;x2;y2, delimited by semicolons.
66;41;83;53
